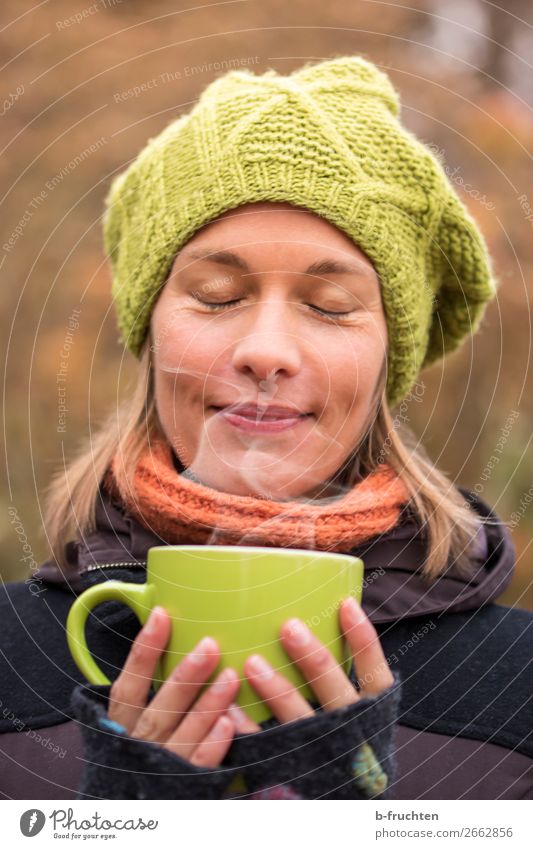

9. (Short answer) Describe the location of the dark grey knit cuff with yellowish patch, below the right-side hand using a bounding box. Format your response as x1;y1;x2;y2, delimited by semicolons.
231;673;401;799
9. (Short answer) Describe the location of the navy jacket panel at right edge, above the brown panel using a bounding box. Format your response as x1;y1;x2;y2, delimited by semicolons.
380;604;533;757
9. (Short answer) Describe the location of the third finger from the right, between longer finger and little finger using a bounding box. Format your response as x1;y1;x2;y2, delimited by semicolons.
244;654;315;722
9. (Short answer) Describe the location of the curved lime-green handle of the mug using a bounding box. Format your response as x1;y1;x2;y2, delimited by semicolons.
66;581;153;684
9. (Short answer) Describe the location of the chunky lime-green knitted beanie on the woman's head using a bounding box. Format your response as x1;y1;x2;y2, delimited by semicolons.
104;56;496;405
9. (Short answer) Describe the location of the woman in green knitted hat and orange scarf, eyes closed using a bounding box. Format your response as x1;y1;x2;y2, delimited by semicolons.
0;57;533;799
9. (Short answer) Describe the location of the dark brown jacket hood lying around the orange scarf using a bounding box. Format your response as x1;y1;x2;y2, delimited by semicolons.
34;487;516;624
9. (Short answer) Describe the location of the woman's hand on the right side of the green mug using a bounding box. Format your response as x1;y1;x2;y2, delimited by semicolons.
230;598;394;734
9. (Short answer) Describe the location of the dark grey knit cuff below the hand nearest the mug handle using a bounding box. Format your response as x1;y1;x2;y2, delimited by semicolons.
71;684;235;799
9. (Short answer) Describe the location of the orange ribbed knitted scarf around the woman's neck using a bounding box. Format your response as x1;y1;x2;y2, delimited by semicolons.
104;441;408;552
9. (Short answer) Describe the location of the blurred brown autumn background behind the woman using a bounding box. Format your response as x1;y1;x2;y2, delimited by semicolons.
0;0;533;609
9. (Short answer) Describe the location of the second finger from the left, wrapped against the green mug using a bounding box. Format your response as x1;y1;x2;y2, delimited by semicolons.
132;637;220;743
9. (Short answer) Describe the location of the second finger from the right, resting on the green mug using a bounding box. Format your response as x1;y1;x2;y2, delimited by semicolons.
281;619;359;710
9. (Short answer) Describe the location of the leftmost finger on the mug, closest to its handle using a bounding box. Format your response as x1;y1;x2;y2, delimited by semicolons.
108;607;170;732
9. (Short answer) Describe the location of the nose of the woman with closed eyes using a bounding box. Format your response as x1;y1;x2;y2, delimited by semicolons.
233;301;302;381
